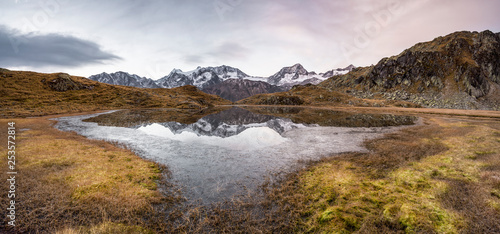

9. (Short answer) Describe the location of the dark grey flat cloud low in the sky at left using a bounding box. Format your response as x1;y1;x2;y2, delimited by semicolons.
0;26;120;68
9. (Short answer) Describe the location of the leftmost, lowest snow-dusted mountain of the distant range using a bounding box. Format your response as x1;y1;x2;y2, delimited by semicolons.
88;71;160;88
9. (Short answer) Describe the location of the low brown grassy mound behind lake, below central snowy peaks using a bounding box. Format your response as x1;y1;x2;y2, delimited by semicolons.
237;85;418;107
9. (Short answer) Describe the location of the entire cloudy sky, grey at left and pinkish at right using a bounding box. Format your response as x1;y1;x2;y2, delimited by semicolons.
0;0;500;79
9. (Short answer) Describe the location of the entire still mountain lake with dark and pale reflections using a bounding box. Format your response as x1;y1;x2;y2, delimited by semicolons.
56;107;417;204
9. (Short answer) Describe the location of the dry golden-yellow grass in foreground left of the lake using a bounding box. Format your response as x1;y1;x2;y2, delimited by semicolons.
0;118;170;233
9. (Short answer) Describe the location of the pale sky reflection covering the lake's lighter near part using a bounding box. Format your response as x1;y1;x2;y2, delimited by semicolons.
52;109;416;203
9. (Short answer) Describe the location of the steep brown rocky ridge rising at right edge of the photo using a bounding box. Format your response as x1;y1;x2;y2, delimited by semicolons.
319;31;500;110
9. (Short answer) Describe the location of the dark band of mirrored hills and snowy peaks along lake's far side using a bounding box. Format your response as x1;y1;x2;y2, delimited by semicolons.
83;107;418;133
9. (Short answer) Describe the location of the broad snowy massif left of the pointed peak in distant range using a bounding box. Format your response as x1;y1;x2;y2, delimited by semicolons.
157;65;249;89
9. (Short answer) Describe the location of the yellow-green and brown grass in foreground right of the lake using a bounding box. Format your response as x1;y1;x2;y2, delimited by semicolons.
281;116;500;233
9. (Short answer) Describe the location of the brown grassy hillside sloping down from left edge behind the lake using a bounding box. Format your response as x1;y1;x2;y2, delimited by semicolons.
0;69;231;118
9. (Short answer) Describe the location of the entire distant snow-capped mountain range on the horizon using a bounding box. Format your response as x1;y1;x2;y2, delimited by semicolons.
89;64;354;94
